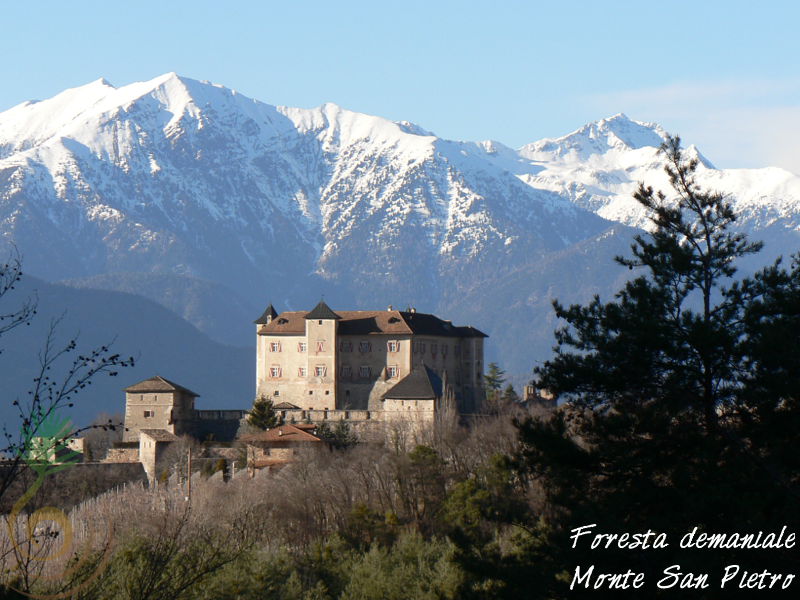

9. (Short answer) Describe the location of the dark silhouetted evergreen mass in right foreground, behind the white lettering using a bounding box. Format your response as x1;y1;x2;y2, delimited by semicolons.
520;138;800;597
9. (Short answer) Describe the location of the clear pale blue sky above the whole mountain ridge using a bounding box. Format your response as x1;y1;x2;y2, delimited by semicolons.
0;0;800;174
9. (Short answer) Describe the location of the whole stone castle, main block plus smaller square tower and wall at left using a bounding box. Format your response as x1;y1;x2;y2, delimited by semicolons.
123;301;487;443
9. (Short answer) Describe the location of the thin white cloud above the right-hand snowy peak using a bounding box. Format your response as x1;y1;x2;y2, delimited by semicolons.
584;79;800;174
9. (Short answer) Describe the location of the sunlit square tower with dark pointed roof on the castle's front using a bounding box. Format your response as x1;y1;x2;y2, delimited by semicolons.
305;300;341;410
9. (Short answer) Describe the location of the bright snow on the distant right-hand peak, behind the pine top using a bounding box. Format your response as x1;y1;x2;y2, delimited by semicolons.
517;114;800;245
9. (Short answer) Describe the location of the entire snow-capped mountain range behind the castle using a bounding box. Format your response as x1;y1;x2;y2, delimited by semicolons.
0;73;800;424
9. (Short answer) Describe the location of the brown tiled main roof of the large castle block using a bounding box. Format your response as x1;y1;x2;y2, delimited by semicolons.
258;306;487;338
